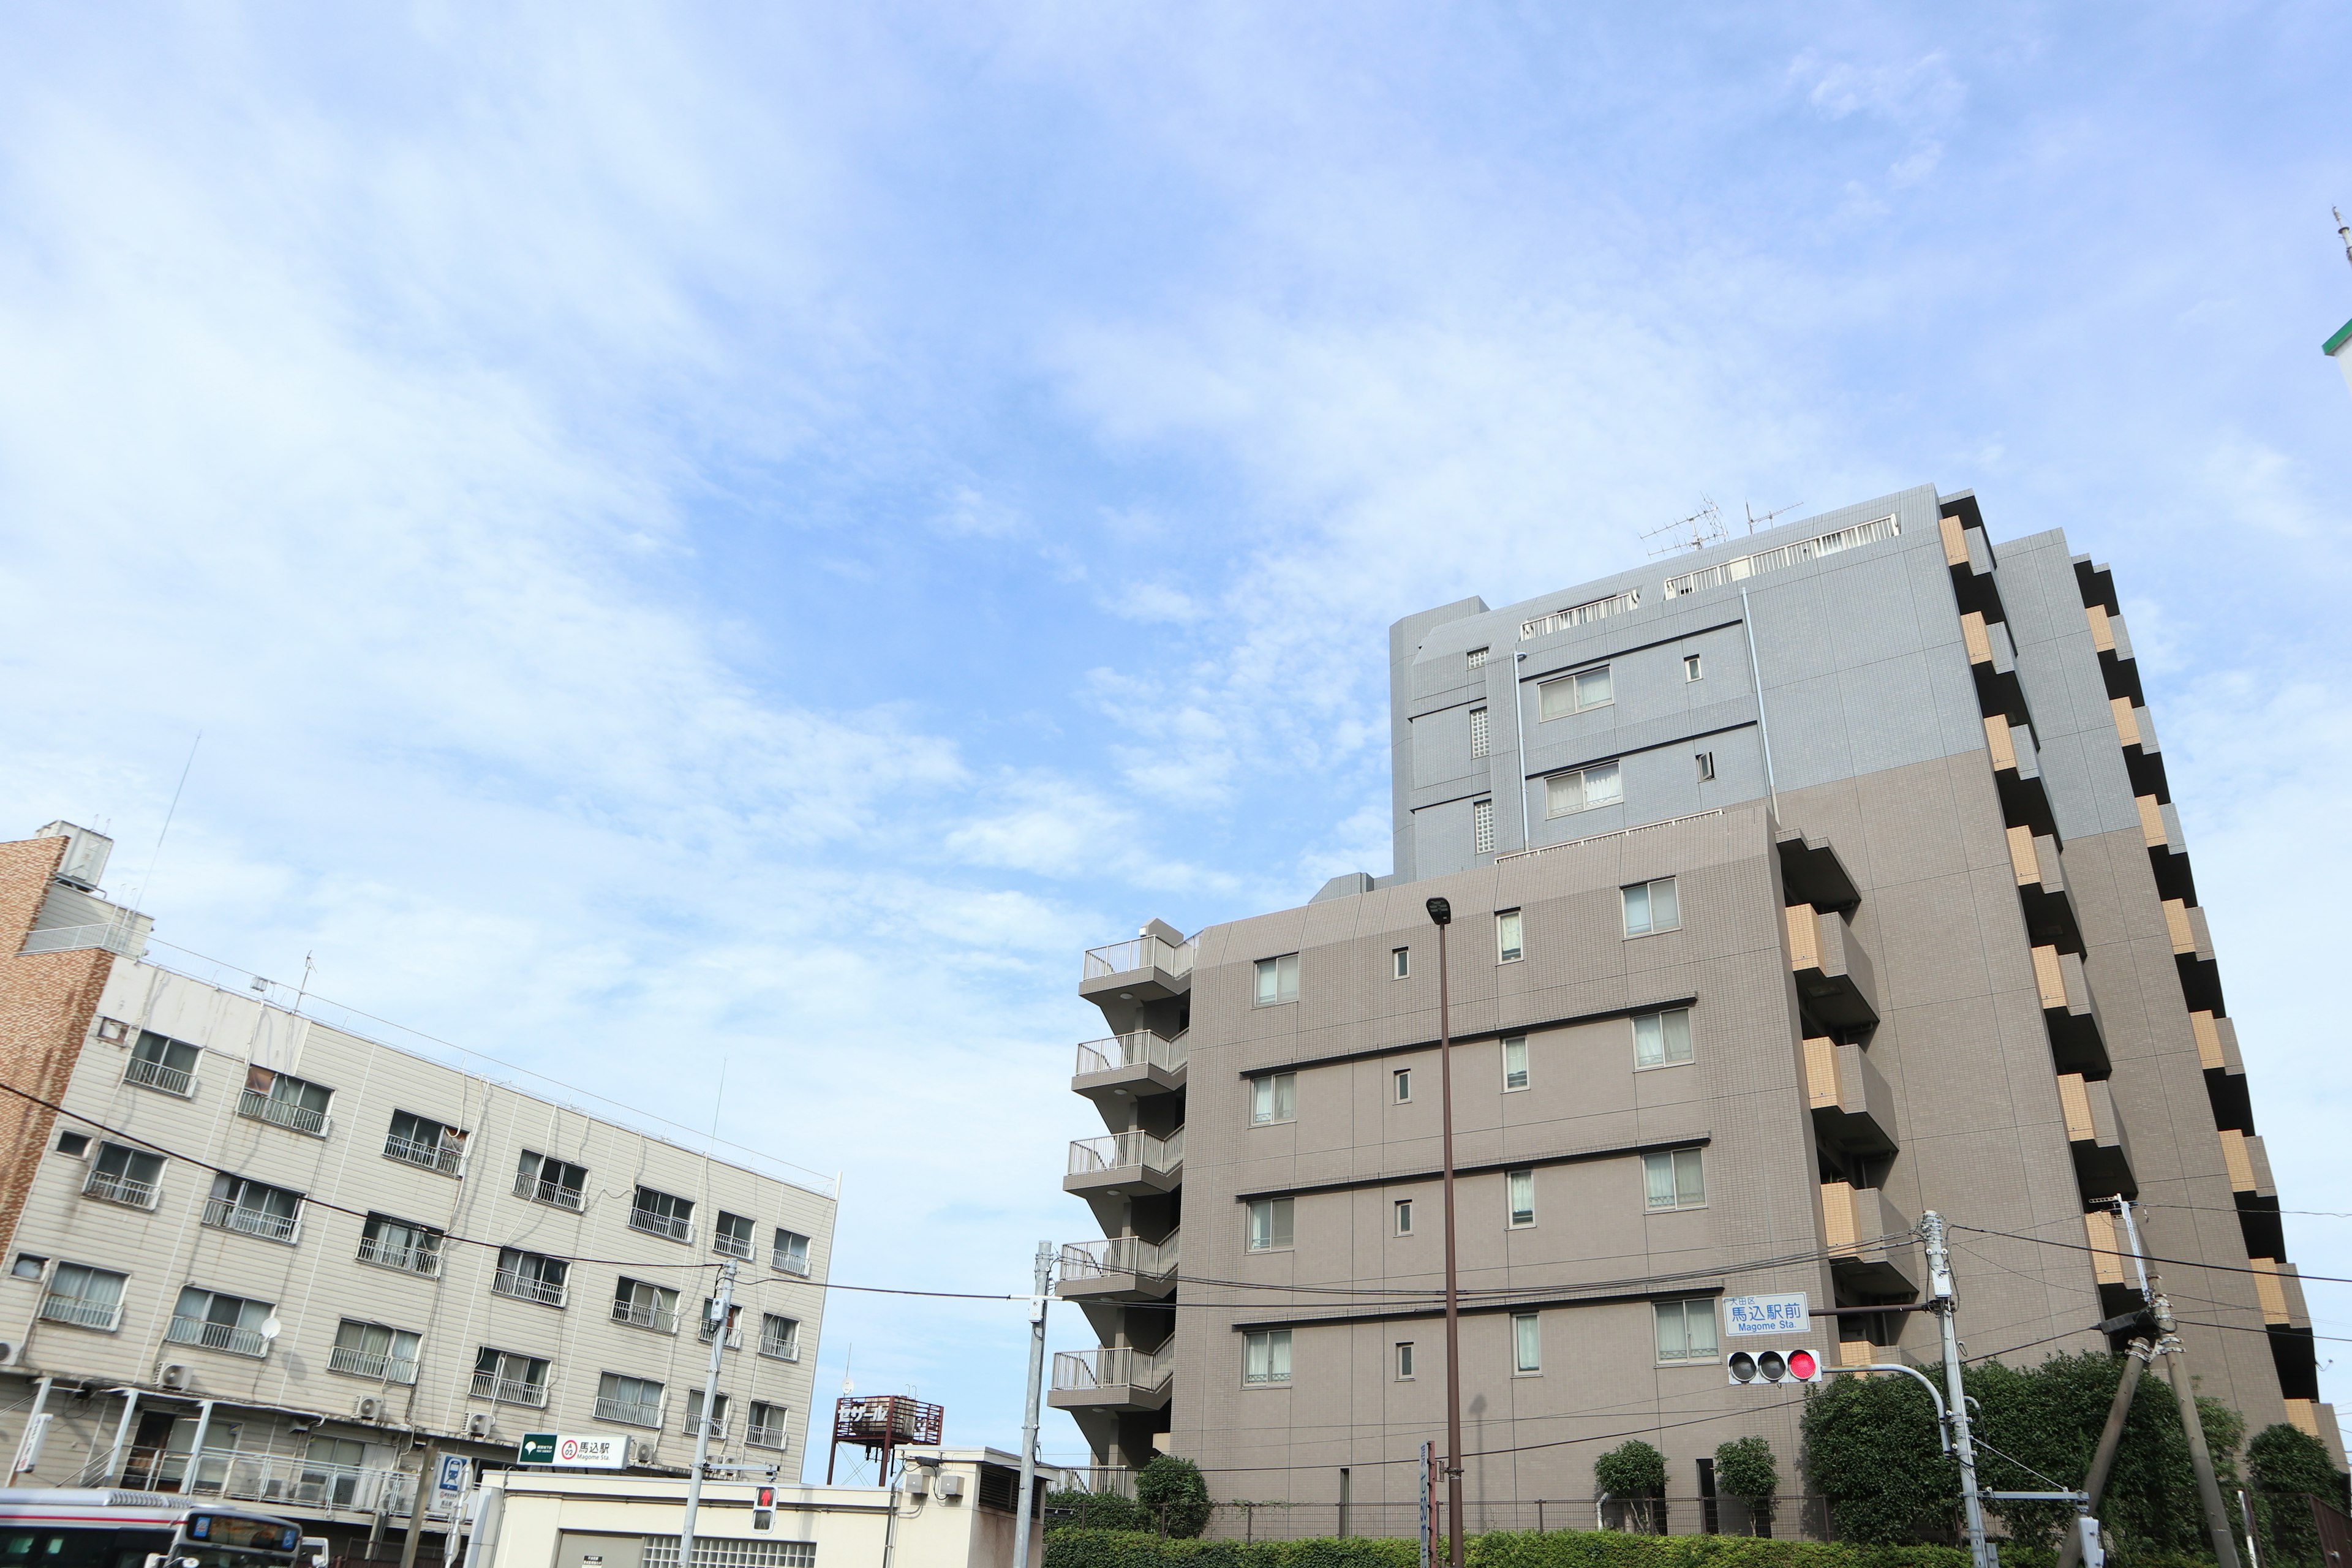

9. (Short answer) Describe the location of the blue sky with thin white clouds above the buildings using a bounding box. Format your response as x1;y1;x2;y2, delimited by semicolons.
0;2;2352;1458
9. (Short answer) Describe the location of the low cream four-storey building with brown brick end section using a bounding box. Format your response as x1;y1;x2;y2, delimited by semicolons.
0;823;835;1545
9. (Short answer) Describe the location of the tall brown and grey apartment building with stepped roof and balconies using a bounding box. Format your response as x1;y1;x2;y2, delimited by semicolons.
1051;486;2340;1531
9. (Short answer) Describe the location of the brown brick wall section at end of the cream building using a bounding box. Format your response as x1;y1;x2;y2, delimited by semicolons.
0;839;115;1248
